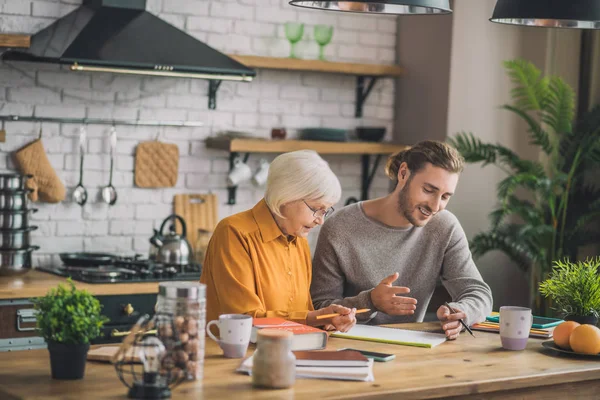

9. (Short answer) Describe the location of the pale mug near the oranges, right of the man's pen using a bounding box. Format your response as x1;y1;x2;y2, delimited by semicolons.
500;306;533;350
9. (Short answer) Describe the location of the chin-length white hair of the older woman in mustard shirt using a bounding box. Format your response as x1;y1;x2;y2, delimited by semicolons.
265;150;342;218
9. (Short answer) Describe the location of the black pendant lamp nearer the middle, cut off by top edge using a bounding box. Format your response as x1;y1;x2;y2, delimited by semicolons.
290;0;452;15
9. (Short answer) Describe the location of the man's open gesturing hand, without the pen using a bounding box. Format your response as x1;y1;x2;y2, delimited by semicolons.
371;272;417;315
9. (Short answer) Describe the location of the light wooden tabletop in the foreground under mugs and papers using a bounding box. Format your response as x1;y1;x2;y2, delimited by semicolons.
0;323;600;400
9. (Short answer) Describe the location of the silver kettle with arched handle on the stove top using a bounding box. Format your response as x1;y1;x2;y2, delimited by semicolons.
150;214;193;265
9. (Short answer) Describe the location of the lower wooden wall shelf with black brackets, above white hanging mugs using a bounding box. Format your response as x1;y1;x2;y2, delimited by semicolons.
206;137;408;204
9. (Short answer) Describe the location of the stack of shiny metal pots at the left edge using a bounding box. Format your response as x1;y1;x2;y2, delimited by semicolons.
0;174;39;275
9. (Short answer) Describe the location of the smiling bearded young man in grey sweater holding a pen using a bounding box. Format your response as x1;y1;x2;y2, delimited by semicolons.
311;141;492;339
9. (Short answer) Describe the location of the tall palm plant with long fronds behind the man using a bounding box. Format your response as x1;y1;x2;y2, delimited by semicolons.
449;60;600;312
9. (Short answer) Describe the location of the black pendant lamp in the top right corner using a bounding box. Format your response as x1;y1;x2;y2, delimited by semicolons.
490;0;600;29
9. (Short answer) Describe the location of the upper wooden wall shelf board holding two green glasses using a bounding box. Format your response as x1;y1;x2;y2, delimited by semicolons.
228;54;405;77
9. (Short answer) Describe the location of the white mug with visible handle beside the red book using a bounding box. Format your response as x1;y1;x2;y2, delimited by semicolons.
206;314;252;358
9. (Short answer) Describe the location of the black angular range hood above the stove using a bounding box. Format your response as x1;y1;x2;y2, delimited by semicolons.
2;0;256;82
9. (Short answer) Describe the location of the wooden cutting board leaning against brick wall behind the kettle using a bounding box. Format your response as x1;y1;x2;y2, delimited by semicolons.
173;194;218;252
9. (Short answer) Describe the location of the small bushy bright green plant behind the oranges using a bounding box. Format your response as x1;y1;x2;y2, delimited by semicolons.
540;257;600;325
